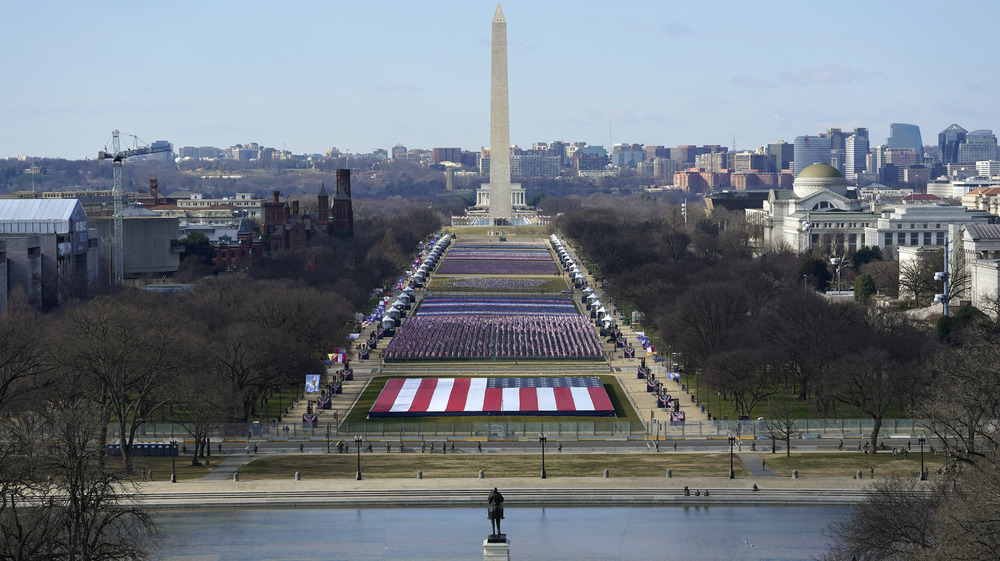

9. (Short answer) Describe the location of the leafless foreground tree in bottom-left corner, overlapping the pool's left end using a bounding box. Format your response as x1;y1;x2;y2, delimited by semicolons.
0;396;156;561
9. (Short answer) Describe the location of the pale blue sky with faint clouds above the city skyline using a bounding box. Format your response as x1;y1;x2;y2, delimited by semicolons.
0;0;1000;159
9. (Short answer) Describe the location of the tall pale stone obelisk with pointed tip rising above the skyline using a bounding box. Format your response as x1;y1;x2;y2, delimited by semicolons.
490;3;513;225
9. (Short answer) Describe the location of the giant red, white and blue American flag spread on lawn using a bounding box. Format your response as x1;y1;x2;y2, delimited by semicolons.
368;376;615;418
